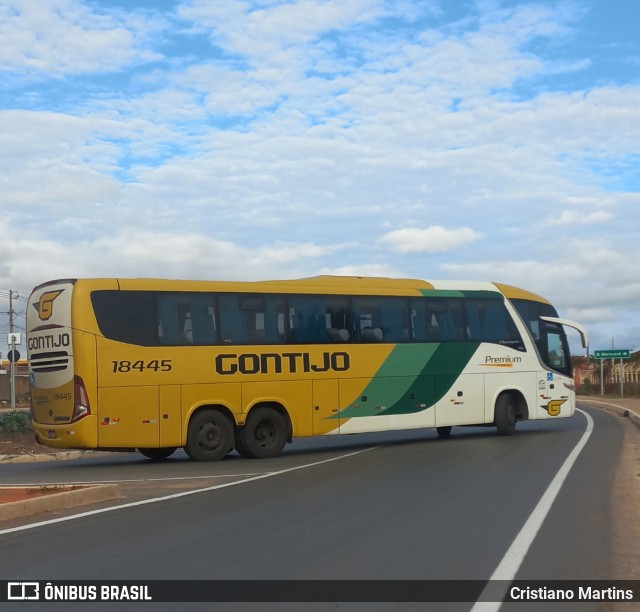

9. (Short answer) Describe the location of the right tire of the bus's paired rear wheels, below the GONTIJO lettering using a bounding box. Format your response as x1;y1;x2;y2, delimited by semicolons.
236;406;287;459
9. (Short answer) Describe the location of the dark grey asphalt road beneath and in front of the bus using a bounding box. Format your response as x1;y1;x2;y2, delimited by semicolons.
0;409;622;611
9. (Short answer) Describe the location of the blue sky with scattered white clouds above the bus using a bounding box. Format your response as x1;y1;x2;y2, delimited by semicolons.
0;0;640;354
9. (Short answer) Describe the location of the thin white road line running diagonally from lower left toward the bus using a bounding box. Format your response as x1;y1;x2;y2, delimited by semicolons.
0;444;386;536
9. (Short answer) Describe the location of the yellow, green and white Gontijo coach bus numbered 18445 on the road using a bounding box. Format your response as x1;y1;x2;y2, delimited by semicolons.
27;276;586;461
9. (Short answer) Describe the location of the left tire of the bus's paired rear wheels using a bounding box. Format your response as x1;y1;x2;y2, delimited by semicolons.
184;410;233;461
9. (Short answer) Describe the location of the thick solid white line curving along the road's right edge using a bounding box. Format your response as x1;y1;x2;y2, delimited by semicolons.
471;408;593;612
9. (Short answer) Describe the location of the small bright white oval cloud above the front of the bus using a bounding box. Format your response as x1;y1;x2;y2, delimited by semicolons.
380;225;481;253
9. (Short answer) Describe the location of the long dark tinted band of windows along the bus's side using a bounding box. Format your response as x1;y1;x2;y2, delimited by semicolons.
92;291;524;350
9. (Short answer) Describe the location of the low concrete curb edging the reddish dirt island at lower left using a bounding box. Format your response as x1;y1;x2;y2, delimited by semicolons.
0;484;122;521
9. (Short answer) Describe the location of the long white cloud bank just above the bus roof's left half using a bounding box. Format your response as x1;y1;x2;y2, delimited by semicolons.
0;221;341;294
